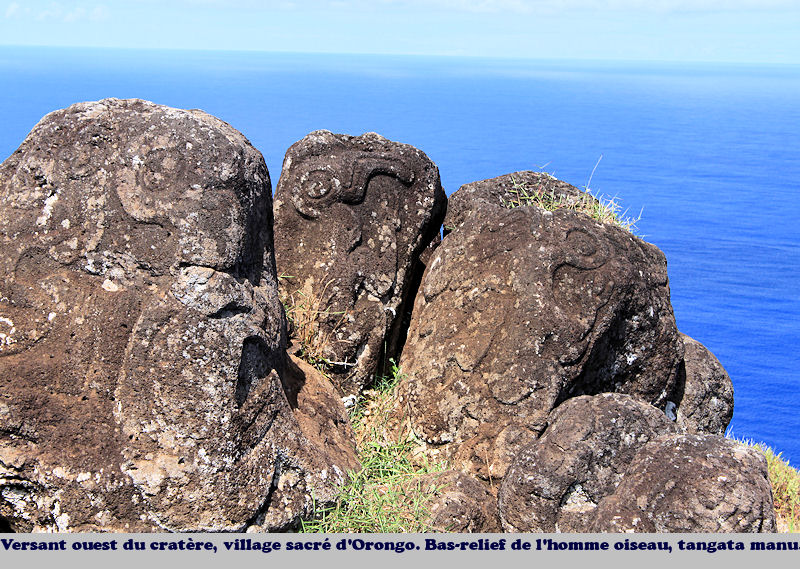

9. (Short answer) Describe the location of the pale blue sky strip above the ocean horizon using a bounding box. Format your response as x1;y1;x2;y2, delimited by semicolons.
0;0;800;64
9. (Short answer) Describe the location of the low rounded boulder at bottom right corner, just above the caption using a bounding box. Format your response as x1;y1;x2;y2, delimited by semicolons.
589;435;775;533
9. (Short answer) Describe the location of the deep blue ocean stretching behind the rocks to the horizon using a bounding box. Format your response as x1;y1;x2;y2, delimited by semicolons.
0;47;800;466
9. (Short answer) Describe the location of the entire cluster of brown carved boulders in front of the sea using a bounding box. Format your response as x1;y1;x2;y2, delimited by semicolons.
0;103;775;532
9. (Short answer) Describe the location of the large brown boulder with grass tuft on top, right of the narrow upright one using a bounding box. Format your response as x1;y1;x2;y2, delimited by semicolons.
399;171;683;472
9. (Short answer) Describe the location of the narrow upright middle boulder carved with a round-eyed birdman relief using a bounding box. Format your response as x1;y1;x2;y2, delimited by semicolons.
274;131;446;394
